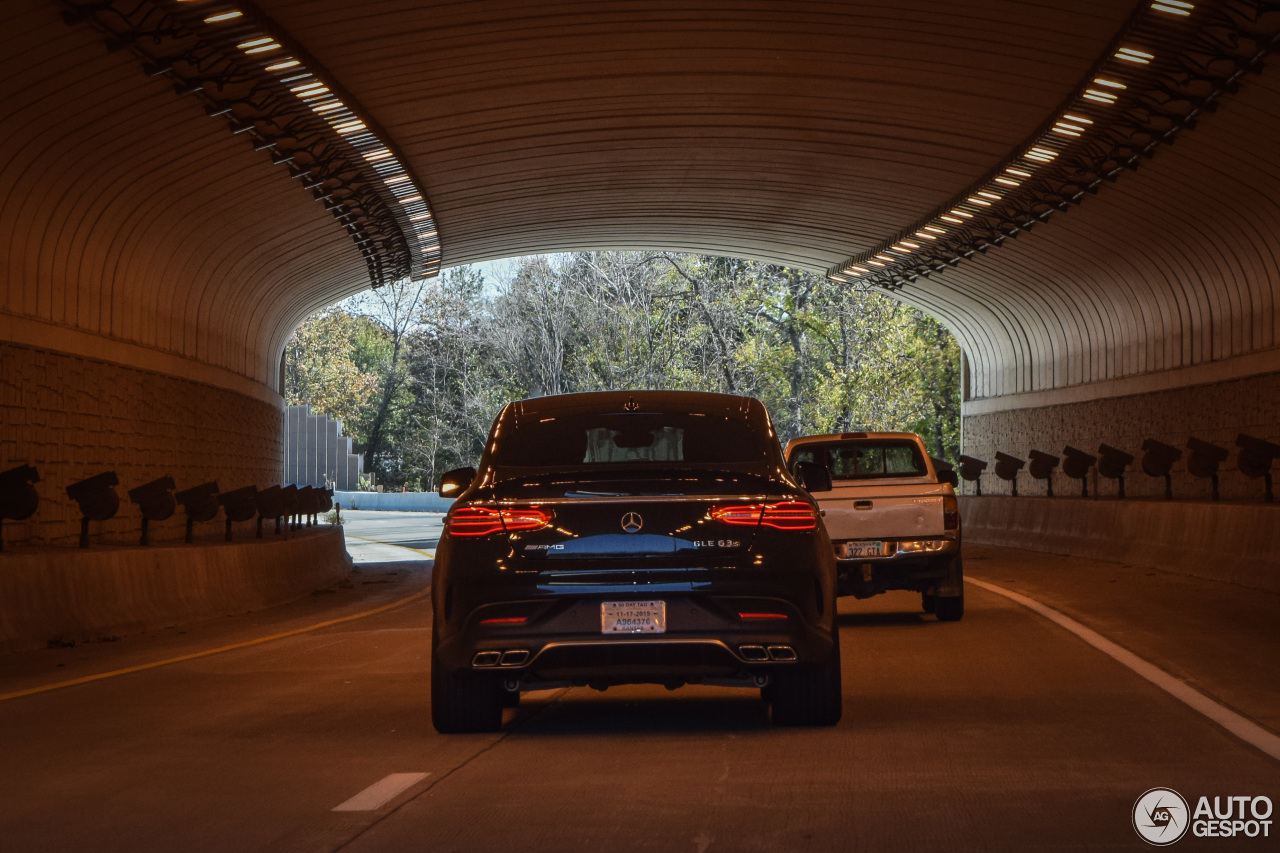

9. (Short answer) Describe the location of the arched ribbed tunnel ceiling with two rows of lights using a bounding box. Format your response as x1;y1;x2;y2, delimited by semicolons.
0;0;1280;397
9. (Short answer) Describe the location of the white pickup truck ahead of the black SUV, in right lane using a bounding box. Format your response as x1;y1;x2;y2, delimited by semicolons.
786;433;964;622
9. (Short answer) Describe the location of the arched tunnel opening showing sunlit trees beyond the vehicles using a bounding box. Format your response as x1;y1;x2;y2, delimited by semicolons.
284;251;960;491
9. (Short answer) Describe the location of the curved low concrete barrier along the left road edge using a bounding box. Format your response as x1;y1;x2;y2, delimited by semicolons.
0;526;351;652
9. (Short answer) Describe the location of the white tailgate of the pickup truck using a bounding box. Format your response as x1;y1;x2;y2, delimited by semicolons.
818;484;946;539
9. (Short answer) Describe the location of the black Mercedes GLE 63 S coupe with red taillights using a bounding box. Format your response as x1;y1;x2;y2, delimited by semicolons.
431;392;841;733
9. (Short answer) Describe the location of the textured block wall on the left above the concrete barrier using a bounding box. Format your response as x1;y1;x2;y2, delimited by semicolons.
0;342;283;551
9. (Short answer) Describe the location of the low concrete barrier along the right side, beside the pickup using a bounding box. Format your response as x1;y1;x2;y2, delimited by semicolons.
960;497;1280;592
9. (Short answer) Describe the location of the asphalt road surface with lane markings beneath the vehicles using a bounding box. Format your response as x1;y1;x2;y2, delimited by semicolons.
0;514;1280;853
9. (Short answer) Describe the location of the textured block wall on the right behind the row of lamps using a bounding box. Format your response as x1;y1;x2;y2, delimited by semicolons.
961;373;1280;501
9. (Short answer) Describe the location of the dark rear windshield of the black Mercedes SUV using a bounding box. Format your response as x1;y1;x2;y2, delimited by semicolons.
492;411;772;469
